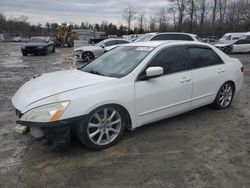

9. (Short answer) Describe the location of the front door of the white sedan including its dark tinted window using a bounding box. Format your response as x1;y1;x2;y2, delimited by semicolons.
135;46;192;126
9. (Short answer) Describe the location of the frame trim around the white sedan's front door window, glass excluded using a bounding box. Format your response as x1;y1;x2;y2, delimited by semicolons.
135;44;190;82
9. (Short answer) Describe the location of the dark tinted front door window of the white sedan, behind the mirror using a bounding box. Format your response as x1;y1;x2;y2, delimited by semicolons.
148;46;187;74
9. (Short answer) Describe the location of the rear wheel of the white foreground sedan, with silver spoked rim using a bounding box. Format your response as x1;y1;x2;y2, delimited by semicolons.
213;82;235;110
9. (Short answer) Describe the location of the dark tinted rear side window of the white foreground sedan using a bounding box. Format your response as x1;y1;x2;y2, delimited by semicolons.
188;47;223;68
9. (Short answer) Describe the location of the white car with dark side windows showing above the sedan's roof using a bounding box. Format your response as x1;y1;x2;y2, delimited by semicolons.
134;32;199;42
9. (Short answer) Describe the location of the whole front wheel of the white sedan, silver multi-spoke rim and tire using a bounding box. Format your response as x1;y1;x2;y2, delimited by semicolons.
77;106;125;150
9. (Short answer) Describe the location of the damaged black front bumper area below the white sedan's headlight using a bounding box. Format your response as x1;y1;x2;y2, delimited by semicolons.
17;115;87;150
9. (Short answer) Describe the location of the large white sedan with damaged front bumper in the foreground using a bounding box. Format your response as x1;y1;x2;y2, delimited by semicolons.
12;41;243;149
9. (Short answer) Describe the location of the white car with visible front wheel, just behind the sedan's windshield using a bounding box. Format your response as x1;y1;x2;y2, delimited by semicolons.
74;38;130;63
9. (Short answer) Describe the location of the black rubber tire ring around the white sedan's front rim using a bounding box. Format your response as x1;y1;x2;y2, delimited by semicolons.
76;105;126;150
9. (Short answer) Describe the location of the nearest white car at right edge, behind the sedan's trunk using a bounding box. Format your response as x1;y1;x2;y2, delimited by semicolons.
214;36;250;54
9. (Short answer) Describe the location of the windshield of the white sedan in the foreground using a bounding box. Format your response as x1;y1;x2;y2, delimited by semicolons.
81;46;154;78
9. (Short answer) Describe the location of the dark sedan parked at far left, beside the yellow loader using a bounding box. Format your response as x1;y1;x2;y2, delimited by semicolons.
21;37;55;56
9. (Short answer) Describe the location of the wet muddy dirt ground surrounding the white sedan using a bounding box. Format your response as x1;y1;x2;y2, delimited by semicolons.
0;43;250;188
